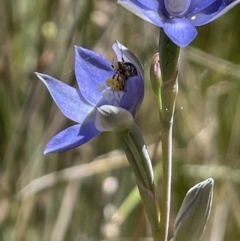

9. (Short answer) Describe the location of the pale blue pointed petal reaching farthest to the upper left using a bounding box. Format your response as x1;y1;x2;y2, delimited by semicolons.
36;73;93;123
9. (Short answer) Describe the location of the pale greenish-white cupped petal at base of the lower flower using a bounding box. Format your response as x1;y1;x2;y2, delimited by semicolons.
95;105;134;131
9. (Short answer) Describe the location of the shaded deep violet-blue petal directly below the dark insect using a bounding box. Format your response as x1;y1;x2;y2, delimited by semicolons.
119;76;144;117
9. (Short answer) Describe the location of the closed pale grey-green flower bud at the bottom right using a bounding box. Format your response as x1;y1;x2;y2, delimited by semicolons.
172;178;214;241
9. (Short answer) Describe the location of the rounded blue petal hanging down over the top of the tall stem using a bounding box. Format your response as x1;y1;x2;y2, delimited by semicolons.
163;18;197;47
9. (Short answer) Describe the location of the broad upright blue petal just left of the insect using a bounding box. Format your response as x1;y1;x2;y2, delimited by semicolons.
75;46;114;105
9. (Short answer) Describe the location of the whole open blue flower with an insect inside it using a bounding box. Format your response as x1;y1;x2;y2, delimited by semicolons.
36;41;144;154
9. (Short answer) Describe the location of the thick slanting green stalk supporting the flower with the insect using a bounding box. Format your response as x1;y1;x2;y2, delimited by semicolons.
117;124;159;235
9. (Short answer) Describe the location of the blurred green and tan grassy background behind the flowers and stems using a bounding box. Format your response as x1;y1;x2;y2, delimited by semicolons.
0;0;240;241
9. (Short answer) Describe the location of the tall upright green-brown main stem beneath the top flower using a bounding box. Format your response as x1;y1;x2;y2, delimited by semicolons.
158;29;180;241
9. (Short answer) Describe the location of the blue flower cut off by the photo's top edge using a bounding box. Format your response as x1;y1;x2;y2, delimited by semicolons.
118;0;240;47
